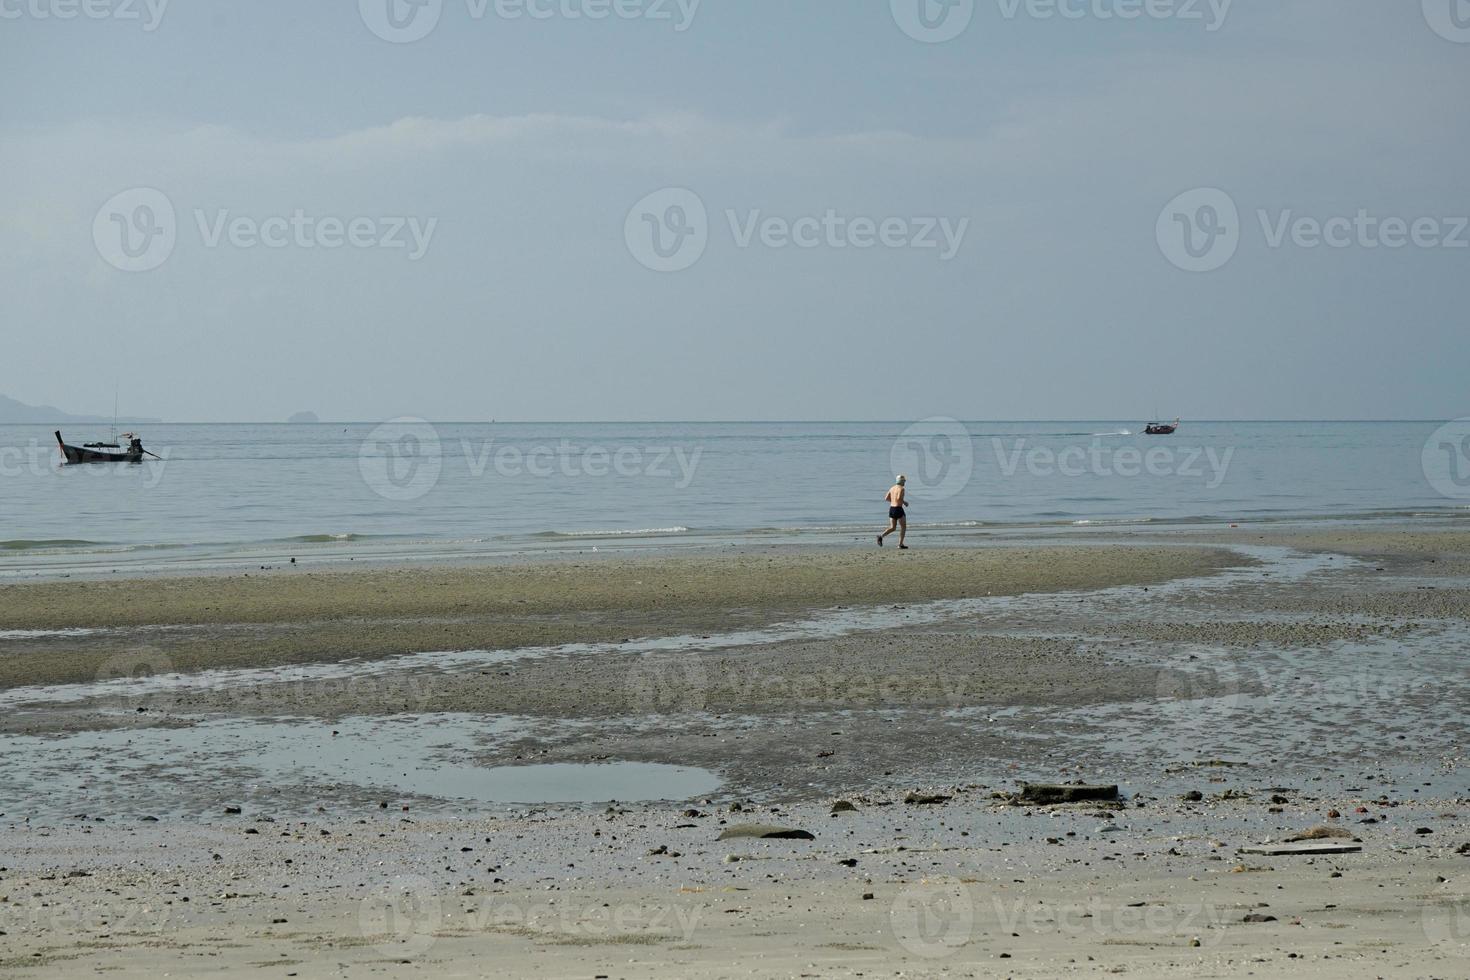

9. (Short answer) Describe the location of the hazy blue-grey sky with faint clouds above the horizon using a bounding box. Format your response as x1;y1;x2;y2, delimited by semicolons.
0;0;1470;422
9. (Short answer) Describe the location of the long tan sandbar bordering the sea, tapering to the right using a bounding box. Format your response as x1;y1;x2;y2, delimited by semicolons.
0;545;1241;691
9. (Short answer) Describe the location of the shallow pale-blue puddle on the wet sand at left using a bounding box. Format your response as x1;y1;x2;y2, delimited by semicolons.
0;714;720;820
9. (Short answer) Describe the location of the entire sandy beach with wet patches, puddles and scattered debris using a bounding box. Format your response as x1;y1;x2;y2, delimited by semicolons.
0;523;1470;977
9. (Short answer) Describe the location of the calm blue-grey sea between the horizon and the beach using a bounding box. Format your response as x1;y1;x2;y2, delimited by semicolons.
0;420;1470;574
